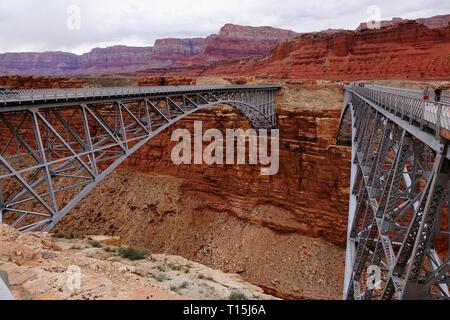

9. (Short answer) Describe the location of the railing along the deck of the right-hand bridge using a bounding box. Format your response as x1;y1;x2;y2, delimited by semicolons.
347;85;450;138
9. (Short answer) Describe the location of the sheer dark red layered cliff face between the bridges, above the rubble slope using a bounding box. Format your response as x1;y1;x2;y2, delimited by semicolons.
113;102;350;245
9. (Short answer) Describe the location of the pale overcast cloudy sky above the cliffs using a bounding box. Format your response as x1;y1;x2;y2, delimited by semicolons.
0;0;450;54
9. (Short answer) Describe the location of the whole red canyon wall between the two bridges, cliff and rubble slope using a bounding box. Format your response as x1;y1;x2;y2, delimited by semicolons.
56;84;350;299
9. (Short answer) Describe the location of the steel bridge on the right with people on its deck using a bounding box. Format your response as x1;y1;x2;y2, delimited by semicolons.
337;85;450;300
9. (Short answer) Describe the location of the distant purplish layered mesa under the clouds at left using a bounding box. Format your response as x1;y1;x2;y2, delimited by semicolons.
0;25;297;75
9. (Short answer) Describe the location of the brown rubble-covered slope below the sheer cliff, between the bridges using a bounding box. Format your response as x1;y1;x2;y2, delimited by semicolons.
55;168;345;299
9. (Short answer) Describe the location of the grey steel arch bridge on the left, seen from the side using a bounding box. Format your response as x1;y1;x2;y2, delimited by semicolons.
0;85;281;231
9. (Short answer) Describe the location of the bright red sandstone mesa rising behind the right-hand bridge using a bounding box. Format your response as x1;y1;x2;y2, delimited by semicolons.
194;22;450;80
